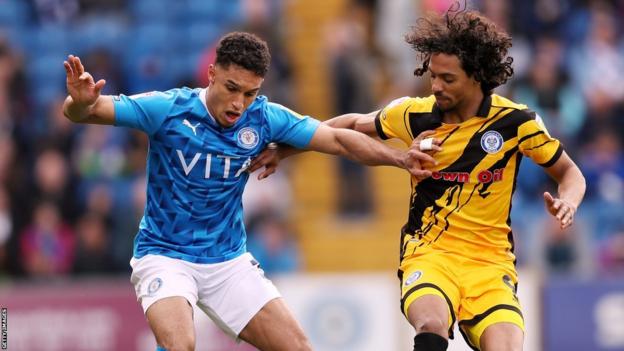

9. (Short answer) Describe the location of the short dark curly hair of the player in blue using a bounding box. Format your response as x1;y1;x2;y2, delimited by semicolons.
215;32;271;77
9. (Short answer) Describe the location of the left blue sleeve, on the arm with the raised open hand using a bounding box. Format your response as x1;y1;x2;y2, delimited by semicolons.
113;91;175;135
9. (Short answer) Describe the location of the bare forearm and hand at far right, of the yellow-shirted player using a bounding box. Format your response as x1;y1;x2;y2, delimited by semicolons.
544;152;585;228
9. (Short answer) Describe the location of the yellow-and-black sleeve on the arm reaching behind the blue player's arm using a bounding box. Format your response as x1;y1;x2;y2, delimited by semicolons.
375;96;413;145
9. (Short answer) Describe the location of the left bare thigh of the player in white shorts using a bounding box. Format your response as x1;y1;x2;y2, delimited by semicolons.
145;296;195;351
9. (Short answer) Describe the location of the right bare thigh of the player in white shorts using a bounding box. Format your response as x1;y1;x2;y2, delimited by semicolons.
239;298;312;351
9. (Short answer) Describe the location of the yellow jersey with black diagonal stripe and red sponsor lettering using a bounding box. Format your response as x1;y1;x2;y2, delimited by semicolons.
375;95;563;262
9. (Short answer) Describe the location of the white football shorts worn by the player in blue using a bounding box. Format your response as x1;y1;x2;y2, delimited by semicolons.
130;252;281;340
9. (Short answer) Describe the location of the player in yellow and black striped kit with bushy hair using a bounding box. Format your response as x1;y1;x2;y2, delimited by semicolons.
252;2;585;351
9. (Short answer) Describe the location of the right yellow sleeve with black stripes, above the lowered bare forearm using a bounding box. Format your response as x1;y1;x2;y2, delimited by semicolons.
518;110;563;167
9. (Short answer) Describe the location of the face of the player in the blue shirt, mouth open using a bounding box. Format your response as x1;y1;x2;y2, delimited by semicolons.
206;64;264;127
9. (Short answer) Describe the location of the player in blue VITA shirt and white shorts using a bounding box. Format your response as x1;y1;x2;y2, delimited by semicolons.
63;32;433;351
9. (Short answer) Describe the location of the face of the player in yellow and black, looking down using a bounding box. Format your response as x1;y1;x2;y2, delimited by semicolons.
429;54;481;112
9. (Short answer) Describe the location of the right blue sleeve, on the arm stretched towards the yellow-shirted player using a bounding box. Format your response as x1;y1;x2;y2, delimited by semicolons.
265;102;321;149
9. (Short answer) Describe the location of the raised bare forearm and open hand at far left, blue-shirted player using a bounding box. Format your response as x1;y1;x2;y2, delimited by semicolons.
63;55;115;124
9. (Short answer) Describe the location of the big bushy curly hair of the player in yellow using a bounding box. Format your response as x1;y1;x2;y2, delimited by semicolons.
405;2;513;95
